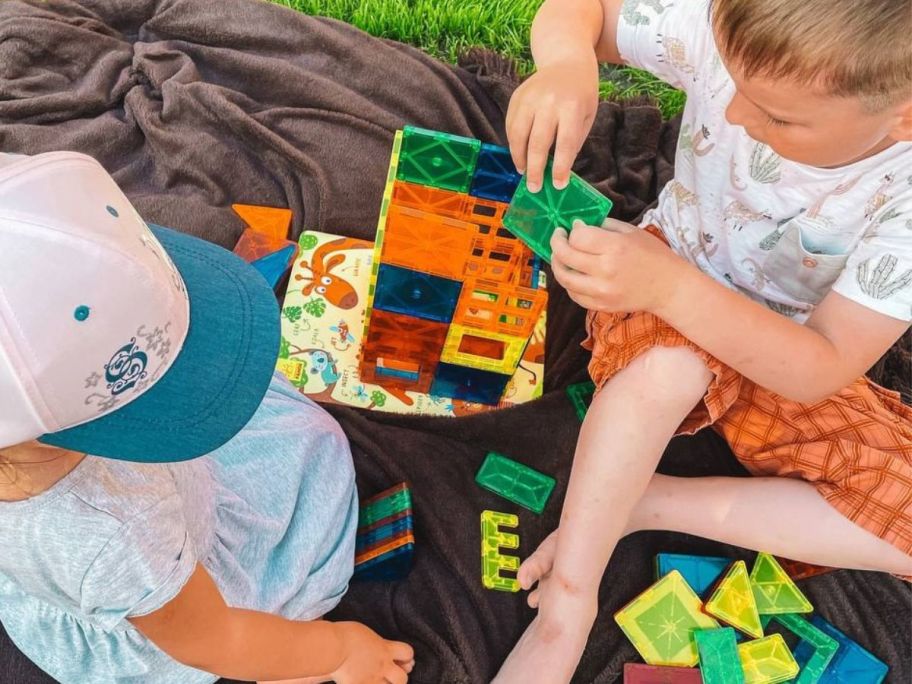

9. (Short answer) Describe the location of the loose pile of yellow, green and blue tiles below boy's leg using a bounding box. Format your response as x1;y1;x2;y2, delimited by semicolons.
615;553;888;684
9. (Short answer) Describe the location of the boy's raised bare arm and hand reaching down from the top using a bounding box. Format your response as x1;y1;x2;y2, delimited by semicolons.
507;0;622;191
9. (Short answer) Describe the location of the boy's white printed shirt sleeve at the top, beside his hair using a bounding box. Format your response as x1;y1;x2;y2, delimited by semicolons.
617;0;718;91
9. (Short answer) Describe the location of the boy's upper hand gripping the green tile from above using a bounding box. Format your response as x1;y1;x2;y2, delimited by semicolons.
507;53;599;192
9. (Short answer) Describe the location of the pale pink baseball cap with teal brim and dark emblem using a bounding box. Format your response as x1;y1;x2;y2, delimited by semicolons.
0;152;279;462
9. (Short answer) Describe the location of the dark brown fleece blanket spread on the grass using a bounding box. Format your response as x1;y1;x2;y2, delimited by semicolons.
0;0;912;684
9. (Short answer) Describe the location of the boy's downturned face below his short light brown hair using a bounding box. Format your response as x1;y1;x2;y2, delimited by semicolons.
725;65;910;168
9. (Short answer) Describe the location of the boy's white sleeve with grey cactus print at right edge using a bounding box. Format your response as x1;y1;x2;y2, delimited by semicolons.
833;197;912;321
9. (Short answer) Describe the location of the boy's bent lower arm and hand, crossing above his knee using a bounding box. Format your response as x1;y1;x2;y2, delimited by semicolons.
551;227;909;403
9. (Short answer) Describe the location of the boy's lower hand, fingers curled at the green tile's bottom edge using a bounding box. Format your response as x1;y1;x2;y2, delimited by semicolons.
551;219;687;313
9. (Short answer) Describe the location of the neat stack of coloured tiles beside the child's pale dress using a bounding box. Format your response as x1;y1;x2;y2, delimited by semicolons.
354;482;415;581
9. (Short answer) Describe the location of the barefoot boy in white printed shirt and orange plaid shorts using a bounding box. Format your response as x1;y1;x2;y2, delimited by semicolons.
497;0;912;684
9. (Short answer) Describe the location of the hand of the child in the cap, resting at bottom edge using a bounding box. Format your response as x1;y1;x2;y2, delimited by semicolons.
332;622;415;684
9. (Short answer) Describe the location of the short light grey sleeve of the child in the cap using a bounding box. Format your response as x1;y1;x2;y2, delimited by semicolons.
80;495;197;631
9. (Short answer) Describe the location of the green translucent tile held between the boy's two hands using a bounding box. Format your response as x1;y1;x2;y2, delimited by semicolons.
503;160;612;263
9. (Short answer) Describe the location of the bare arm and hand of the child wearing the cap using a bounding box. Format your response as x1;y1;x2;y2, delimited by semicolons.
130;566;413;684
